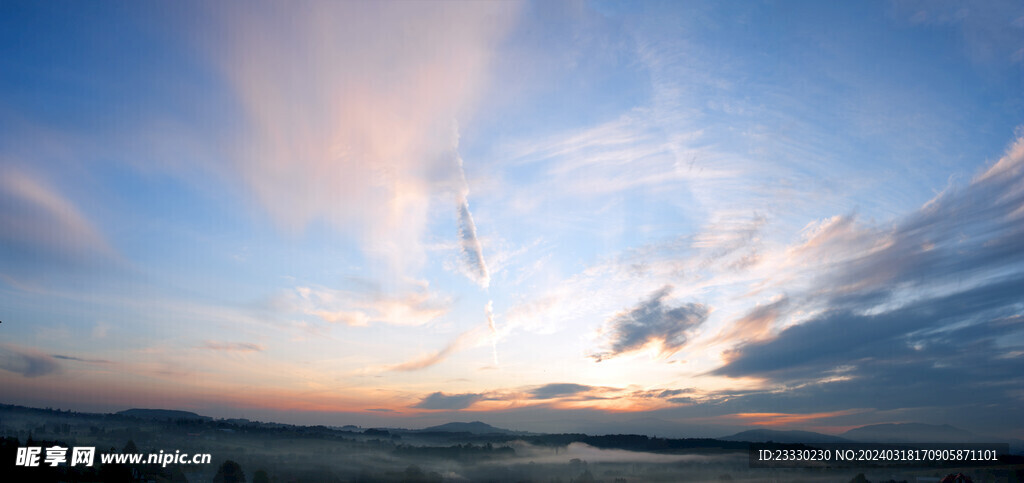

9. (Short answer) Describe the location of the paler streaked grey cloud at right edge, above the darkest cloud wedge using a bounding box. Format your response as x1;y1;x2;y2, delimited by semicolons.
820;140;1024;298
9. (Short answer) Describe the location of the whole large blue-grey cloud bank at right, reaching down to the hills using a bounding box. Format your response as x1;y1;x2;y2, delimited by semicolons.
692;140;1024;433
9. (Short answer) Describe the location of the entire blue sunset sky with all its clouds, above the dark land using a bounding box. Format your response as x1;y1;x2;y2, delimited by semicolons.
0;2;1024;436
